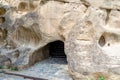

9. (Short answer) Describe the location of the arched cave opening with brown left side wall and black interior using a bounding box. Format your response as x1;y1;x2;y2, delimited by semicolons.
30;40;67;64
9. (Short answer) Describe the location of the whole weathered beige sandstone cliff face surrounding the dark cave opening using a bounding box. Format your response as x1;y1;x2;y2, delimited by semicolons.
0;0;120;80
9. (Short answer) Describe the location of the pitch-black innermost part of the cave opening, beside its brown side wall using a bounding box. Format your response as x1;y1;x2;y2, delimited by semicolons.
49;41;66;58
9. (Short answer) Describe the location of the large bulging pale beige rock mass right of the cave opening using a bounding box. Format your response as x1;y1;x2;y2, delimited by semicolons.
65;4;120;80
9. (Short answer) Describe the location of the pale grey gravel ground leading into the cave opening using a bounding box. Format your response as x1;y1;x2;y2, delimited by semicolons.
0;58;73;80
